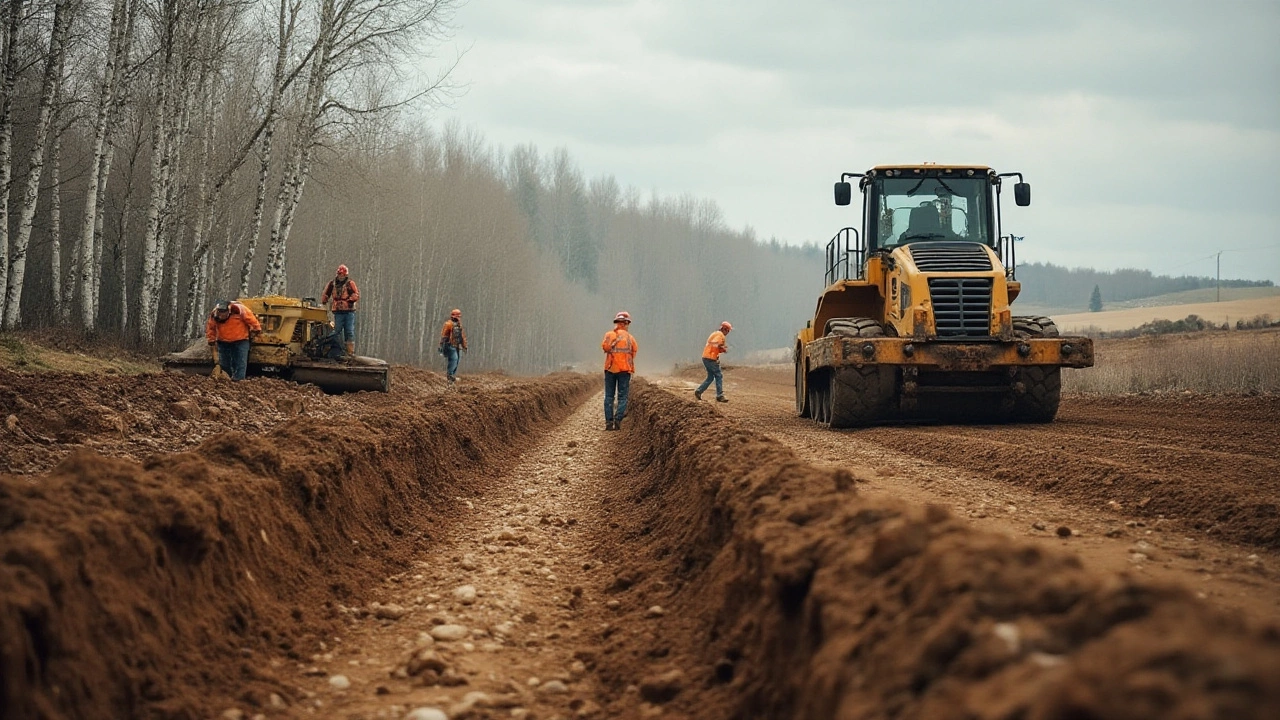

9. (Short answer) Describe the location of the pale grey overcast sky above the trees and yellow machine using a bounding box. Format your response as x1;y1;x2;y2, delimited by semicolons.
432;0;1280;282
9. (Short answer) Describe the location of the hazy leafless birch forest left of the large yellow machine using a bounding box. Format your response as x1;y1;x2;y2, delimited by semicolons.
0;0;822;372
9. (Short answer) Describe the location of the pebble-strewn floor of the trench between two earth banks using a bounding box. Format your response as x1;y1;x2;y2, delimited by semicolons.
282;395;635;720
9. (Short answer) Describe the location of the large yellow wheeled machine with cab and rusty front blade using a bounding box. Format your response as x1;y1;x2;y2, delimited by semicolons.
795;164;1093;428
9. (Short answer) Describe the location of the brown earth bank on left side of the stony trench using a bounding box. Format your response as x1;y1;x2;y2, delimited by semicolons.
0;374;594;717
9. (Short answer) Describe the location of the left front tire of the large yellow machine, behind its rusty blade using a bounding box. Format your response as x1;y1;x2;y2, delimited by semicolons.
809;318;897;428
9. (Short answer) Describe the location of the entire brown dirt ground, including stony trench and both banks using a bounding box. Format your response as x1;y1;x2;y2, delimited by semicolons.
0;368;1280;720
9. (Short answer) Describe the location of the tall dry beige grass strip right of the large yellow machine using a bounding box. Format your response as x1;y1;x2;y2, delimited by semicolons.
1062;329;1280;395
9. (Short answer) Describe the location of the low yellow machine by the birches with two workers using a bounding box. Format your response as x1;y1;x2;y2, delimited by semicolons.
164;295;392;393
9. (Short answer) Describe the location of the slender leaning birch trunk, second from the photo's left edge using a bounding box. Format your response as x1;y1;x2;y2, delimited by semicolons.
4;0;70;331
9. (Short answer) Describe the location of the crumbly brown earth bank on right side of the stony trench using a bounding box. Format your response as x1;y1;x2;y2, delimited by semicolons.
598;383;1280;719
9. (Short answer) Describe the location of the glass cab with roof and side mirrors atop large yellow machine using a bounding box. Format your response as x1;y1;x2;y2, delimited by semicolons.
836;165;1030;255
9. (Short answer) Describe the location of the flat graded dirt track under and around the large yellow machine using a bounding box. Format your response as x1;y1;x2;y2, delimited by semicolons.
662;368;1280;620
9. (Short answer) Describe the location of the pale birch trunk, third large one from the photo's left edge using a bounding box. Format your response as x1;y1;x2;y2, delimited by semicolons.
74;0;132;331
